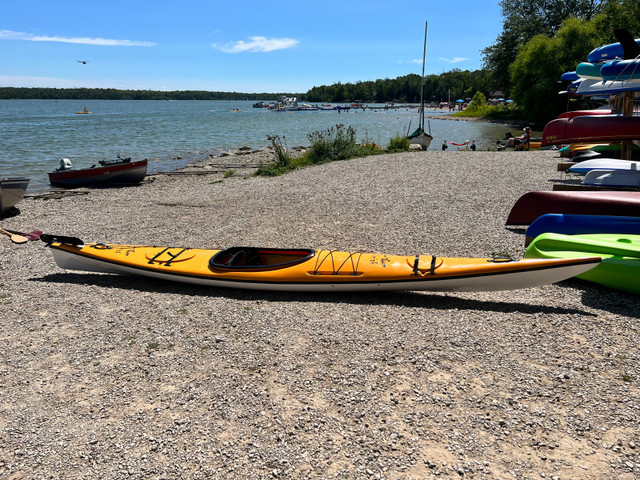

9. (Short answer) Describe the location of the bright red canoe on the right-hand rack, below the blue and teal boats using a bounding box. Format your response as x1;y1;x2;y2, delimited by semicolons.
542;115;640;146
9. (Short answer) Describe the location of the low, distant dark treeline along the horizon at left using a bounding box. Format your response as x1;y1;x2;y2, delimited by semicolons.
0;87;293;101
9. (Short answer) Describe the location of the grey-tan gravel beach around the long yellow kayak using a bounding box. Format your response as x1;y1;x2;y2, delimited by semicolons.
0;150;640;480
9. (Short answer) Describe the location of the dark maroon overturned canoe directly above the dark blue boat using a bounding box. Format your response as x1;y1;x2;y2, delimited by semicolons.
506;191;640;225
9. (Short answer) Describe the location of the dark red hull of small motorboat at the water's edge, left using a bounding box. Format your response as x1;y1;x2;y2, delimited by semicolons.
49;160;147;187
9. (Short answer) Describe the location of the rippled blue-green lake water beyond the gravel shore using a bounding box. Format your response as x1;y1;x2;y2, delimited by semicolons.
0;100;517;192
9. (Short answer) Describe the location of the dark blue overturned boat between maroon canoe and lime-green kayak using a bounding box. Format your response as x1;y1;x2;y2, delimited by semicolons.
525;213;640;245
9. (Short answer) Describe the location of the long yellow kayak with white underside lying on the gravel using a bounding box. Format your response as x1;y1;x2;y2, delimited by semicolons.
41;235;599;292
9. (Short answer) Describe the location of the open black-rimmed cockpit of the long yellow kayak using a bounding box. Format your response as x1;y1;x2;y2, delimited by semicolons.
209;247;316;270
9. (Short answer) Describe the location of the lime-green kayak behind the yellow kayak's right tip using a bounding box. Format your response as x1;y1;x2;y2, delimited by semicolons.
525;233;640;293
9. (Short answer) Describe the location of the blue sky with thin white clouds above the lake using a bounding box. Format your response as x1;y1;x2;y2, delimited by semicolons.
0;0;502;93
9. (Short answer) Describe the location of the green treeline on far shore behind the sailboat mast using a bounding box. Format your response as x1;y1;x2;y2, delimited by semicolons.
303;69;492;103
